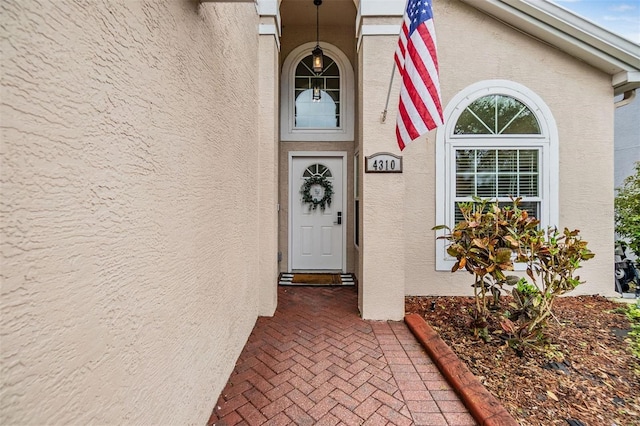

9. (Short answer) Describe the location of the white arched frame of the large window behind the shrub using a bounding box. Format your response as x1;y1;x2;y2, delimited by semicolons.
436;80;559;271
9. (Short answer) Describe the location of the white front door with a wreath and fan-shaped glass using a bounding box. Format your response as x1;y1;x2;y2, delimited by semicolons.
289;153;346;272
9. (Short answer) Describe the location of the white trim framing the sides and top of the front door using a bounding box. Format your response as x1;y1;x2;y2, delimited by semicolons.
287;151;348;273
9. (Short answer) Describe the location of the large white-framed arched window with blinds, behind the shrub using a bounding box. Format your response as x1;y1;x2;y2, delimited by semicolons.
436;80;558;270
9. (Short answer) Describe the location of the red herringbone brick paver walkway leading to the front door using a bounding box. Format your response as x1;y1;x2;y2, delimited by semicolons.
208;287;476;426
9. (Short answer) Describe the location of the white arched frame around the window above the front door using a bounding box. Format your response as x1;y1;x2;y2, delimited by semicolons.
280;42;354;142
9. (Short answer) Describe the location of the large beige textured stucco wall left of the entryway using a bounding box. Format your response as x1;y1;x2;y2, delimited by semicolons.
0;0;259;425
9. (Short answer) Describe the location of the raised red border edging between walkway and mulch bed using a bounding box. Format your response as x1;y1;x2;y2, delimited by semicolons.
404;314;518;426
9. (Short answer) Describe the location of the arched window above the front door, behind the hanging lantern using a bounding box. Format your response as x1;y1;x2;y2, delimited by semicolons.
280;43;354;141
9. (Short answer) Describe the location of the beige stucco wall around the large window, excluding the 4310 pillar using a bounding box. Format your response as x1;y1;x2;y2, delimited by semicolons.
402;0;614;295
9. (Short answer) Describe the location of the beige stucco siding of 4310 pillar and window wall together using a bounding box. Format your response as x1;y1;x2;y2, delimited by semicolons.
358;0;615;306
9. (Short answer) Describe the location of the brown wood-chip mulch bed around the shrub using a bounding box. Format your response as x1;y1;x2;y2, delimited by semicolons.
405;296;640;426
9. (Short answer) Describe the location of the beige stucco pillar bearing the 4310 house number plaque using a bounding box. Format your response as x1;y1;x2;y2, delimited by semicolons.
358;32;408;320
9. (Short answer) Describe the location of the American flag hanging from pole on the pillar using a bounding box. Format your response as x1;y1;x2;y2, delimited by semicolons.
395;0;443;151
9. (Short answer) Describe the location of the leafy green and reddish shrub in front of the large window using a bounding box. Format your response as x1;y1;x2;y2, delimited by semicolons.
434;199;594;347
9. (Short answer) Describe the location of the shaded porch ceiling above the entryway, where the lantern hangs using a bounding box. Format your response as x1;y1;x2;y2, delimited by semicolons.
280;0;356;27
